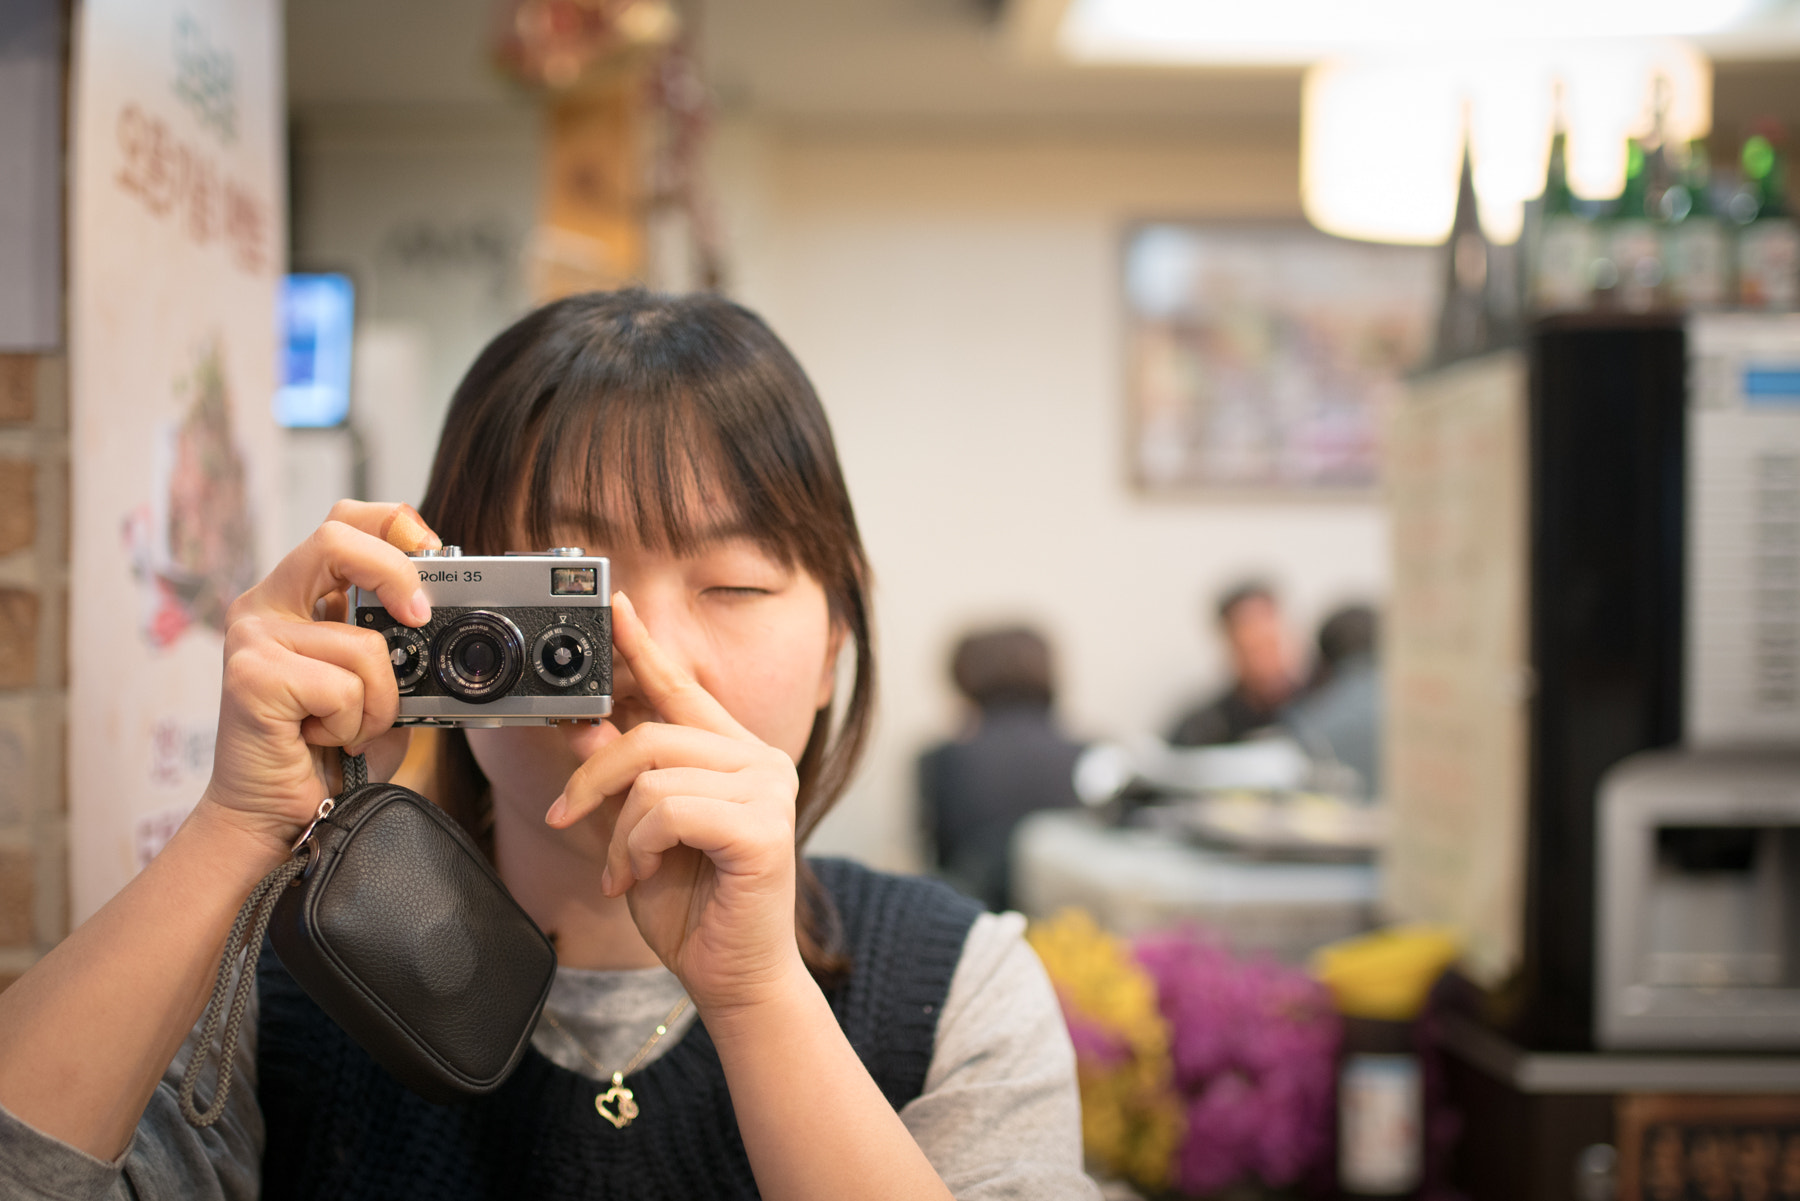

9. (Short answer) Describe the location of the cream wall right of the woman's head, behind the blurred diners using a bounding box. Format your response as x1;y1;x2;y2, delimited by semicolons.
713;124;1386;868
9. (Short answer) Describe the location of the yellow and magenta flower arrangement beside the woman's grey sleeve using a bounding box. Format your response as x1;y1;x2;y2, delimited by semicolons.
1031;911;1341;1196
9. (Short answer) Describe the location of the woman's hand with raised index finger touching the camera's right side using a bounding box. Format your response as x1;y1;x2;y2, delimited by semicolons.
545;592;806;1014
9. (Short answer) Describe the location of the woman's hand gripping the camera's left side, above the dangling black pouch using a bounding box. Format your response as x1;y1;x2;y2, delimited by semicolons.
200;501;437;868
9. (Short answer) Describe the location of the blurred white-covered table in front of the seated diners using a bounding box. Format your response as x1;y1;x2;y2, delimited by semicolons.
1012;810;1379;963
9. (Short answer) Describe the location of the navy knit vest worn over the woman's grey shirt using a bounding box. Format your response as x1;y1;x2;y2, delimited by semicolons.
257;859;981;1201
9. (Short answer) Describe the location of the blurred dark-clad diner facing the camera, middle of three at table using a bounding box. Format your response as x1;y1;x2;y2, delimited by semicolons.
1168;580;1298;747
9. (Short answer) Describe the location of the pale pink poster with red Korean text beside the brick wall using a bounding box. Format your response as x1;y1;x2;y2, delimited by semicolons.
68;0;286;922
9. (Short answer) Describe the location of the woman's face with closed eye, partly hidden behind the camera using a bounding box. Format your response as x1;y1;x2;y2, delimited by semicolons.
457;528;842;834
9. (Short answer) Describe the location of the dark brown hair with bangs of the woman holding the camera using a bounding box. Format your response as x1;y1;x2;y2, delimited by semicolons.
419;288;875;976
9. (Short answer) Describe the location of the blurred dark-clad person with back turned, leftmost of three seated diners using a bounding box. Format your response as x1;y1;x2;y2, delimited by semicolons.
918;627;1082;913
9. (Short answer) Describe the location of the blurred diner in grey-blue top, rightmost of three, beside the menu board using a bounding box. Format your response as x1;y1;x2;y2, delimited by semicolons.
1282;605;1381;799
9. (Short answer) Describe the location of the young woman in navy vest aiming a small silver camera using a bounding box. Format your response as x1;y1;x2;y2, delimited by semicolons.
0;292;1096;1201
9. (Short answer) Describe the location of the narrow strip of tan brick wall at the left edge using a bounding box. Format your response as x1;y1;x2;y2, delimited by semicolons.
0;355;68;989
